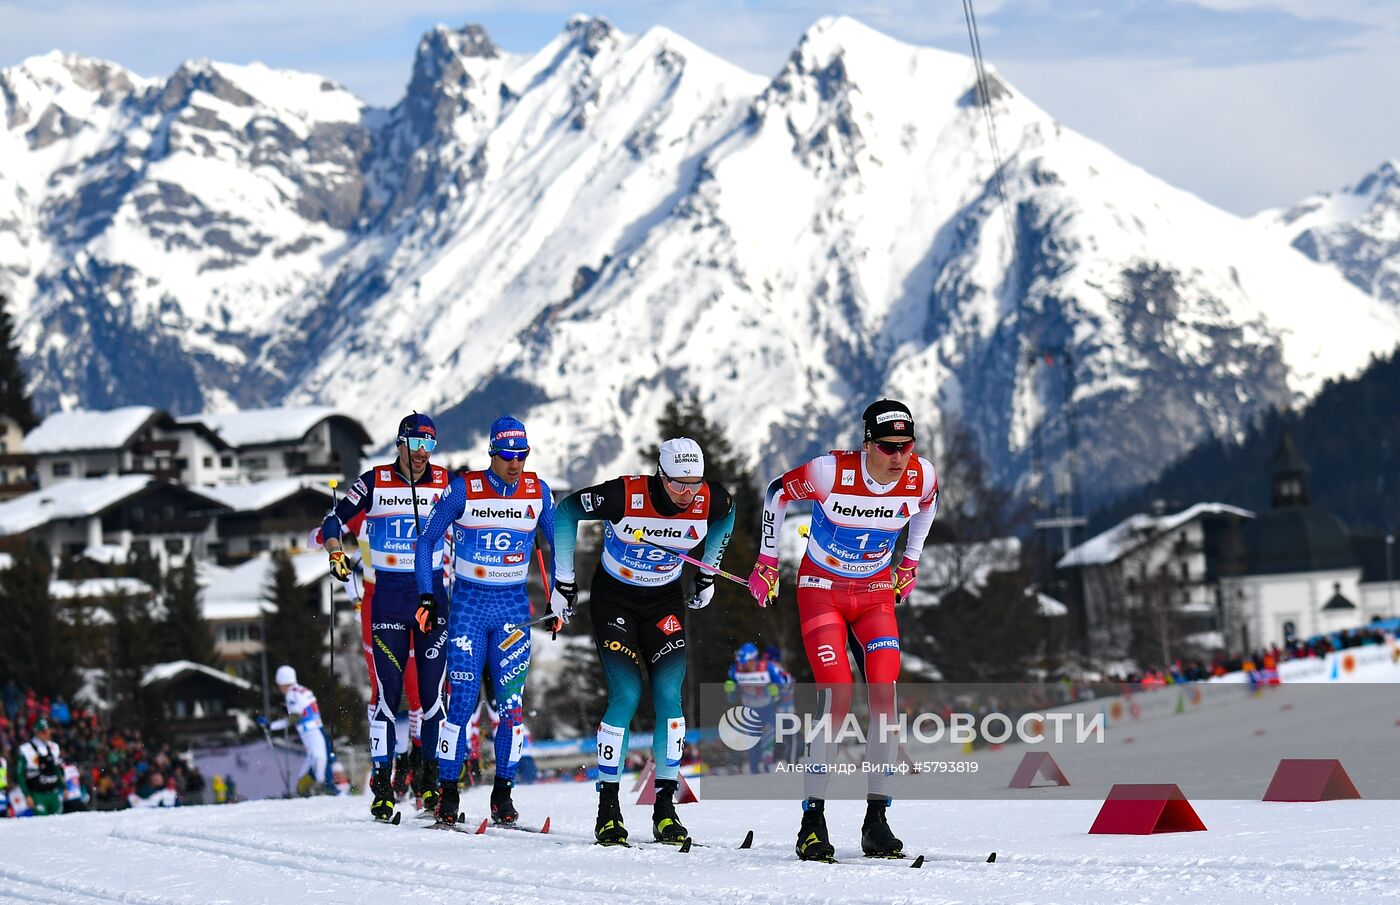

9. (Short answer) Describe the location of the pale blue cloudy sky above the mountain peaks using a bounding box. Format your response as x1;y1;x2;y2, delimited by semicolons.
0;0;1400;214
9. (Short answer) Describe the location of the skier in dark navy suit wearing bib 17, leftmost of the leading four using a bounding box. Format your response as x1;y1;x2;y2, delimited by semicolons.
321;412;448;820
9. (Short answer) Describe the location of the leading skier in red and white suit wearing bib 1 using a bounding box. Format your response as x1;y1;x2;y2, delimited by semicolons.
749;399;938;860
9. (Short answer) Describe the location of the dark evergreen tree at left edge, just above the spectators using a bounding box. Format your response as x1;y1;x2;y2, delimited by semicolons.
0;544;78;698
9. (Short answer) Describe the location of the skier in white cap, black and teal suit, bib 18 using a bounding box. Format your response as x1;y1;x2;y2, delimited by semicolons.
550;437;734;845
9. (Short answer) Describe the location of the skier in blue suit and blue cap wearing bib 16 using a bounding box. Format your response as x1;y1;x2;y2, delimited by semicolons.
417;416;554;824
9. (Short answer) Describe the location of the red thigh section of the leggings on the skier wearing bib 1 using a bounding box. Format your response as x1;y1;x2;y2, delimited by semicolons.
797;559;899;720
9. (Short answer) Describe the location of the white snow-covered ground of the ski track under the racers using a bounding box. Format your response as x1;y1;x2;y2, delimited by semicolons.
0;783;1400;905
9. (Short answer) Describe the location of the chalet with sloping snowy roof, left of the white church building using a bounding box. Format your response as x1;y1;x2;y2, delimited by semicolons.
1056;503;1254;663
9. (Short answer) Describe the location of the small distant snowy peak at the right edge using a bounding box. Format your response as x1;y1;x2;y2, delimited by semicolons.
1256;160;1400;315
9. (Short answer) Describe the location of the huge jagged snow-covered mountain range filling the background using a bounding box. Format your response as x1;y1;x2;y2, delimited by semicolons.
0;17;1400;504
